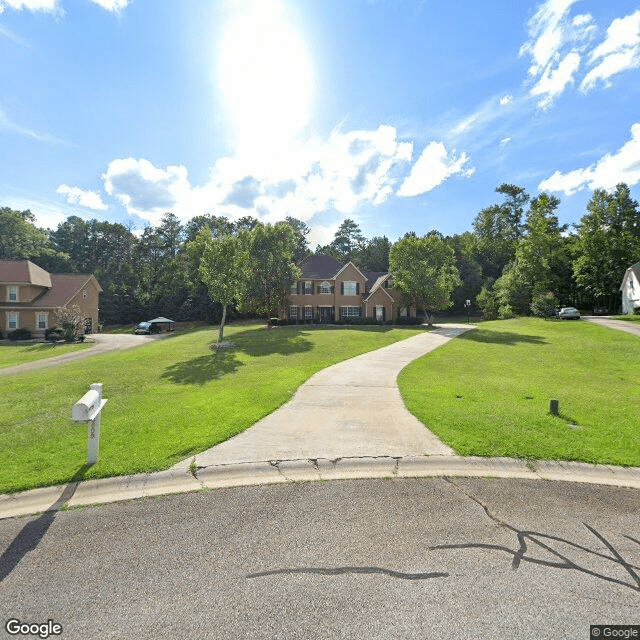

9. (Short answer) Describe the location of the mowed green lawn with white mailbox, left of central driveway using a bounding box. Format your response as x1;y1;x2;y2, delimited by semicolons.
0;325;424;492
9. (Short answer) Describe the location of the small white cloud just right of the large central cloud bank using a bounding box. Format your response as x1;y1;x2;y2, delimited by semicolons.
398;142;475;197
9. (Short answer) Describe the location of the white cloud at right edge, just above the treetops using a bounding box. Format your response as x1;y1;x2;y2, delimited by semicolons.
538;123;640;196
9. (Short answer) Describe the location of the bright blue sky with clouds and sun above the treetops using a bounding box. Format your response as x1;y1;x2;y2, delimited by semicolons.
0;0;640;247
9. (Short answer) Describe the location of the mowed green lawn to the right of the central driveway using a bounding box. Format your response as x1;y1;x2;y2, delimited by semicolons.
398;318;640;466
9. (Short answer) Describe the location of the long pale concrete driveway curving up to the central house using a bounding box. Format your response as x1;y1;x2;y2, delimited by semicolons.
176;324;475;468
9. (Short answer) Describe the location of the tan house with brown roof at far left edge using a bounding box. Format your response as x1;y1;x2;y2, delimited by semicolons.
0;260;102;336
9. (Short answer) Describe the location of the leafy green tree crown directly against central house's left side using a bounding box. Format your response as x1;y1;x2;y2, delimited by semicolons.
239;222;300;318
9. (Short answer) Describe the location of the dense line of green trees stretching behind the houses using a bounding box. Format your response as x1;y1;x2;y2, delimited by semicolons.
0;183;640;324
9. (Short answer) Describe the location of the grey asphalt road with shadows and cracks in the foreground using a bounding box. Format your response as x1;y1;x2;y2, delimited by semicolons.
0;478;640;640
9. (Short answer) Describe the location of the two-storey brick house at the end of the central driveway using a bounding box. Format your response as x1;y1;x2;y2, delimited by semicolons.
280;256;416;323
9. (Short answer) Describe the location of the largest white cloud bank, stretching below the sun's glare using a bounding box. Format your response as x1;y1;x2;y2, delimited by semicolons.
97;125;413;223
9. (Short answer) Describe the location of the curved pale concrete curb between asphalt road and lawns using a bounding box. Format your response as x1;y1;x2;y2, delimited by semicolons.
0;456;640;519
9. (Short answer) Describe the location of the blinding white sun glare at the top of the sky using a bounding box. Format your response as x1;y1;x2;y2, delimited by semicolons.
218;0;312;159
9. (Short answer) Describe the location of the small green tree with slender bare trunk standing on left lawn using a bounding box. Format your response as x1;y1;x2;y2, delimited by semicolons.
199;230;248;344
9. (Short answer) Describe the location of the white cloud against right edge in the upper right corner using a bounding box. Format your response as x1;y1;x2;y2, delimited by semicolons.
580;10;640;93
